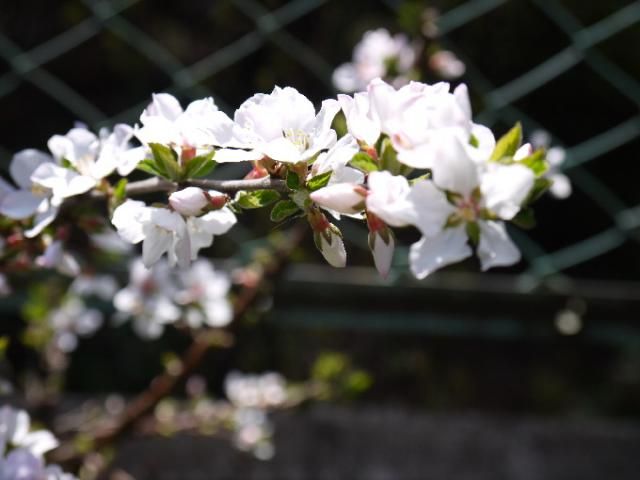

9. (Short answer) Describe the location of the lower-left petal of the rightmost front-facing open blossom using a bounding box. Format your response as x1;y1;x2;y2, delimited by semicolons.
409;226;471;279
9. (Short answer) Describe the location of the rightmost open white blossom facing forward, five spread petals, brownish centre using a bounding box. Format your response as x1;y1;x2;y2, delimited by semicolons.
409;137;534;278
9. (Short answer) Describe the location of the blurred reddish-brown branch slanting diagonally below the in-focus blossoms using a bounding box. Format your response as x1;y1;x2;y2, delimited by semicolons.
51;224;307;467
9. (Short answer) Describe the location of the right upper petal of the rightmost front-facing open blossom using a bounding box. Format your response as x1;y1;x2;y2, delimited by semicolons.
480;165;535;220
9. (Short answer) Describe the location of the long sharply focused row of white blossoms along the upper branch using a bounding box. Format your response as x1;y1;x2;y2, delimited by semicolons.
0;78;551;282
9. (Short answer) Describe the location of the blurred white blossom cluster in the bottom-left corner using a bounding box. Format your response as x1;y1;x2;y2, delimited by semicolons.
0;406;76;480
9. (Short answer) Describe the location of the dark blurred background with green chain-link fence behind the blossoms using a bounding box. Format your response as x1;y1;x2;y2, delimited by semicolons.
0;0;640;479
